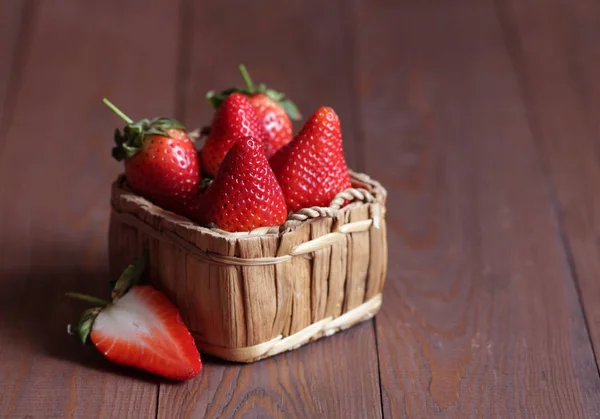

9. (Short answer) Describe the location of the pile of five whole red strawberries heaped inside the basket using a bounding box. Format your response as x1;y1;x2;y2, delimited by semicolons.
104;66;351;232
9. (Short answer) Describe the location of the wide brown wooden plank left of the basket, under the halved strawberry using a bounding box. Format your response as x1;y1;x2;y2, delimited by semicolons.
0;0;178;418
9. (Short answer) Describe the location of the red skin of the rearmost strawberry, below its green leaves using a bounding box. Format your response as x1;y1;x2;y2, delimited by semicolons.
249;93;292;158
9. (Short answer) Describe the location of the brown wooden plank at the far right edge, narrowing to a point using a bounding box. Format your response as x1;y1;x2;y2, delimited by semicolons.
498;1;600;370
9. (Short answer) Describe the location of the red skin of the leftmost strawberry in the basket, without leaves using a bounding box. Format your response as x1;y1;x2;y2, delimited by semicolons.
125;129;201;212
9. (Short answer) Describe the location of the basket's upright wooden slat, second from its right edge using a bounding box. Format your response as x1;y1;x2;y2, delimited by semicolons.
344;205;370;312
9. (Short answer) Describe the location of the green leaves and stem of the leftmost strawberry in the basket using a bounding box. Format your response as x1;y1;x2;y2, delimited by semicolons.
102;98;185;161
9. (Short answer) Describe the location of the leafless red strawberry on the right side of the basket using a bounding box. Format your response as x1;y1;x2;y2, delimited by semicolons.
270;107;351;211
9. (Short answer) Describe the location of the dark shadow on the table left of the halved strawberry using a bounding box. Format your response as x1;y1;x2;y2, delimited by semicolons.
0;266;158;383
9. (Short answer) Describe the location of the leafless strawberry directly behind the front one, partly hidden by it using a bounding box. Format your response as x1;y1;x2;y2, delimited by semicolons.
201;93;264;178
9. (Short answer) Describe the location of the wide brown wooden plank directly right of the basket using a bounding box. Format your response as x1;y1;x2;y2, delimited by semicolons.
356;0;600;418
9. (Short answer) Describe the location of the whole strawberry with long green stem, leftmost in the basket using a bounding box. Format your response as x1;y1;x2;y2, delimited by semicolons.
104;99;201;211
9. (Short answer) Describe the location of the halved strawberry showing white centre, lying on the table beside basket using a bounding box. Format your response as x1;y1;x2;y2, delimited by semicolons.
68;251;202;380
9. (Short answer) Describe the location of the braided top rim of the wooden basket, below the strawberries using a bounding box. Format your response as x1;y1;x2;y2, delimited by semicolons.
111;170;387;240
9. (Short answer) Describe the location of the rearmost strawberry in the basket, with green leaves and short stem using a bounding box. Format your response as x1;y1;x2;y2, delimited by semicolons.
206;65;301;158
